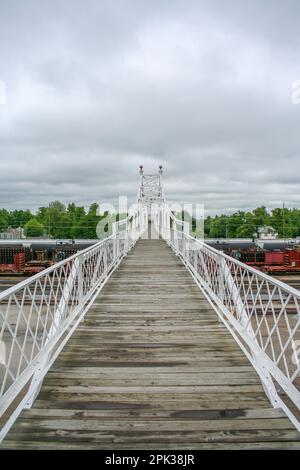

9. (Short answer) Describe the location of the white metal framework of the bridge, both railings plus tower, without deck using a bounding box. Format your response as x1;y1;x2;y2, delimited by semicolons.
0;167;300;441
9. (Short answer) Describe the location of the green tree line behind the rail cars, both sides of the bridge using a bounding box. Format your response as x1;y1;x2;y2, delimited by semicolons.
0;201;300;238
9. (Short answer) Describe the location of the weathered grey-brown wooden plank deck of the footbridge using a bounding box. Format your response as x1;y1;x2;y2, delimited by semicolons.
2;240;300;450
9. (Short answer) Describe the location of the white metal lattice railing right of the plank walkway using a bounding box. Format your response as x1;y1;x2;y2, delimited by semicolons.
161;207;300;431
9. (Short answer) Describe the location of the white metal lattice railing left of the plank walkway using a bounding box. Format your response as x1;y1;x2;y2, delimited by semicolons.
0;211;144;442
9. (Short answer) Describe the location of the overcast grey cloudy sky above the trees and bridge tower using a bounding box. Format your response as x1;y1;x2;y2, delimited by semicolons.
0;0;300;213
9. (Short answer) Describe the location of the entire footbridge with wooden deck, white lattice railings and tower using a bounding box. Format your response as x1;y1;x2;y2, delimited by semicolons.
0;167;300;450
